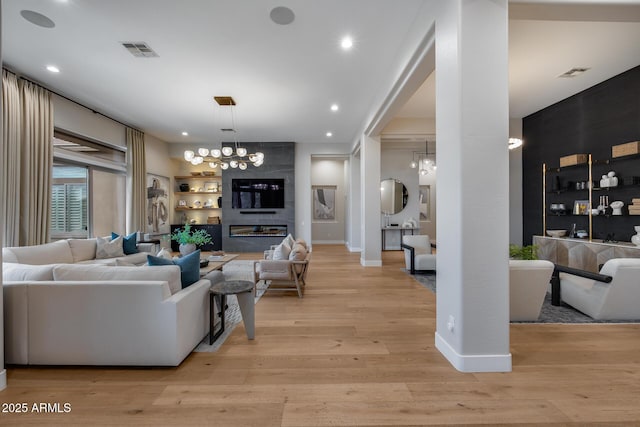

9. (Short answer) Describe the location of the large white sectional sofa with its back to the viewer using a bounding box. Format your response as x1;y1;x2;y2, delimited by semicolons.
3;241;210;366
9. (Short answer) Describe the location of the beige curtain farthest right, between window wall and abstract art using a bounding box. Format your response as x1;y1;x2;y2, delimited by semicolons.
127;128;147;233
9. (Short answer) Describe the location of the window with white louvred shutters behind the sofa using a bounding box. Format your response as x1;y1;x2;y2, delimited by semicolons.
51;163;89;239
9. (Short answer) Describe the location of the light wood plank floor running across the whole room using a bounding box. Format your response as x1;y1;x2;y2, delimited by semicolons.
0;245;640;427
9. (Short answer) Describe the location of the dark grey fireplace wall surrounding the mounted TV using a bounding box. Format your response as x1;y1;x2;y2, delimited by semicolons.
222;142;295;252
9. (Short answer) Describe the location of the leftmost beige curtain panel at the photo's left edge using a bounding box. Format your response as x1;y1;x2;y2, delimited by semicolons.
0;70;21;247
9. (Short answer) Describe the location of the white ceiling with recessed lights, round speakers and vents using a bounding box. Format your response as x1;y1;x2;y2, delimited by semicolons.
2;0;640;147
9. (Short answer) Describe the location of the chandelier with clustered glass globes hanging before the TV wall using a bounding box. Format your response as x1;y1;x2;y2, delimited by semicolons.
184;96;264;170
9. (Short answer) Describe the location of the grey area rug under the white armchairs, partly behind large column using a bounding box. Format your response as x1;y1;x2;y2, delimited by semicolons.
410;269;640;323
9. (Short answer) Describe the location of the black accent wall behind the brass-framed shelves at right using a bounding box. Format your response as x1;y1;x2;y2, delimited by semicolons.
522;66;640;244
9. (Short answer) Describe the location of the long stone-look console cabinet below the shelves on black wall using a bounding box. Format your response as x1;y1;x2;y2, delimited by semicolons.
533;236;640;273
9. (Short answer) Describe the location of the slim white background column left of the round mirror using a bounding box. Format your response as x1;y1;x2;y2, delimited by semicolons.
360;135;382;267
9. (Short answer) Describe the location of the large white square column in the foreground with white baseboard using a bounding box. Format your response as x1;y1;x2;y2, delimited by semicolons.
436;0;511;372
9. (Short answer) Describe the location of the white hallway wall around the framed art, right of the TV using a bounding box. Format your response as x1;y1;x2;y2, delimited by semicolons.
310;158;348;244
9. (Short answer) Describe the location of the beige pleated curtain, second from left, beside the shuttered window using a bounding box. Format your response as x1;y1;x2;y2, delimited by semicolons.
18;80;53;246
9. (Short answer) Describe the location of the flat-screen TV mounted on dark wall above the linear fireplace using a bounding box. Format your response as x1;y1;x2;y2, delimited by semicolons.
231;178;284;209
